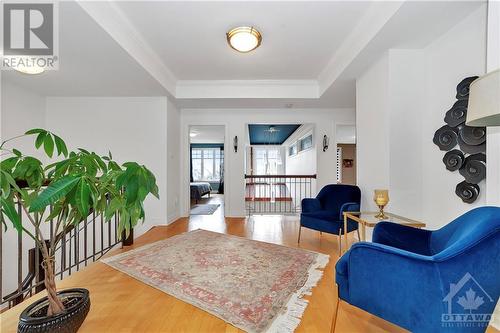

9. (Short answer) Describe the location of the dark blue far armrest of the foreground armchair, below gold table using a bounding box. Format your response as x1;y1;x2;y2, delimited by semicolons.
372;222;432;255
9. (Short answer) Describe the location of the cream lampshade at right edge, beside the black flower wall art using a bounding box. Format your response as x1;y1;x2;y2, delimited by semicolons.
465;69;500;126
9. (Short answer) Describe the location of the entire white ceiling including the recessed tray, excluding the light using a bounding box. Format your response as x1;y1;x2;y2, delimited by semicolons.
2;0;484;108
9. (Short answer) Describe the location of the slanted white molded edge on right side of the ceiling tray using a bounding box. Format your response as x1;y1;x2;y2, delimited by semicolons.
318;1;405;96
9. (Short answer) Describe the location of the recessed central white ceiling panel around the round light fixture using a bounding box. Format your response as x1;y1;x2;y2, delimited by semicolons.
114;1;369;80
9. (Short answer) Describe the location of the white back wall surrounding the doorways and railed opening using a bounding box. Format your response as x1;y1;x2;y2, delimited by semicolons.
181;109;354;216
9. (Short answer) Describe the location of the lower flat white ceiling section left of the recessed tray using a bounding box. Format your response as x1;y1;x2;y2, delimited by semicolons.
2;1;166;96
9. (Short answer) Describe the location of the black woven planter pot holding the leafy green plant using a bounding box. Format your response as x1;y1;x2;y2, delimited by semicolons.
17;288;90;333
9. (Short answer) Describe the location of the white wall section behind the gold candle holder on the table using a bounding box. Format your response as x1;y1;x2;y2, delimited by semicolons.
356;50;424;218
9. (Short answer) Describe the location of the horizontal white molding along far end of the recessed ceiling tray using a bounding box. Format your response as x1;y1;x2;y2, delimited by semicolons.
175;80;319;99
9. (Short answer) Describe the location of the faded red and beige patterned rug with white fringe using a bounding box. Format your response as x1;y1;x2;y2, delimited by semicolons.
102;230;329;332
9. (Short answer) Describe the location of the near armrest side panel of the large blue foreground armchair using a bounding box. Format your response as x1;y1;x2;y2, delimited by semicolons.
339;242;445;331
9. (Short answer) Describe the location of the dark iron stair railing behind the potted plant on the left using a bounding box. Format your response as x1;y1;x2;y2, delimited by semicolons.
0;203;122;308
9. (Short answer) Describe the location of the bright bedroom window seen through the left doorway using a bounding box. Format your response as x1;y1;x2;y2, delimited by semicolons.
191;148;224;182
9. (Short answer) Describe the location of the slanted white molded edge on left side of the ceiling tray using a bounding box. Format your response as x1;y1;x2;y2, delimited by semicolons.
77;0;177;95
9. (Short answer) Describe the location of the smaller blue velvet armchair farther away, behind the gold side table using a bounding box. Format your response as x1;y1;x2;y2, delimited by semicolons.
298;184;361;251
